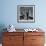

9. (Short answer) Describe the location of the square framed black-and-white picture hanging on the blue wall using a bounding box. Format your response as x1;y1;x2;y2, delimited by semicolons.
17;5;35;23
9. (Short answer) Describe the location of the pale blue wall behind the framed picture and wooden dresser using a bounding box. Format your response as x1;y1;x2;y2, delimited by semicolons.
0;0;46;28
